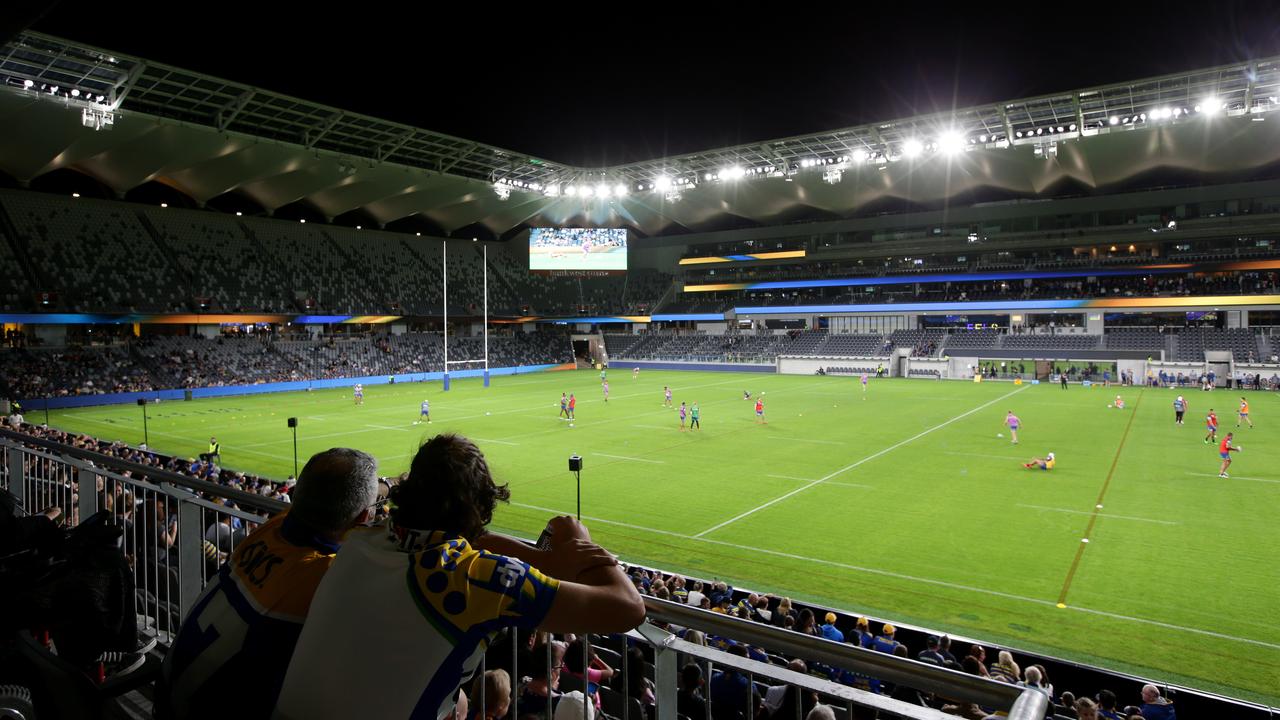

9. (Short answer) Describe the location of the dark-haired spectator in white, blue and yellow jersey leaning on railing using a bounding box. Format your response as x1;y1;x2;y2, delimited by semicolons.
276;434;645;719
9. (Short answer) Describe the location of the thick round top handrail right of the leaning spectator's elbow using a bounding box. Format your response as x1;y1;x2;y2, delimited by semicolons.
644;597;1048;717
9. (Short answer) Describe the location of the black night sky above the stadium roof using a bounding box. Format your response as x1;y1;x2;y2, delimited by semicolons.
6;1;1280;165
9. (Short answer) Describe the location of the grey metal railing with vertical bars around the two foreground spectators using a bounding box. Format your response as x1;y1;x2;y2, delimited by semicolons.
0;429;1270;720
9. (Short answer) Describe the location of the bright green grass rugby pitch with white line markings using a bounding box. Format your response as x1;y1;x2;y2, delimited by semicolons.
45;369;1280;705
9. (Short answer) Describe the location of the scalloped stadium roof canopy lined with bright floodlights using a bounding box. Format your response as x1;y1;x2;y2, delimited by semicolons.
0;32;1280;234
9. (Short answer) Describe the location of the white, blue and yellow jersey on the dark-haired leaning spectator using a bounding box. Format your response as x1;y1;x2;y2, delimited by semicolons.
276;523;559;720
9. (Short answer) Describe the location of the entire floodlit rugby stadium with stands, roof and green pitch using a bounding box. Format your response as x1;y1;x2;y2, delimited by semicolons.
0;8;1280;720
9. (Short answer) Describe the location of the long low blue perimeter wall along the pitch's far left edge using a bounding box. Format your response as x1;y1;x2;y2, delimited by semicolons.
18;365;562;413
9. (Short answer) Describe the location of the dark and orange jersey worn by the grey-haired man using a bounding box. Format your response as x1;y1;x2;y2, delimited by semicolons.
164;512;338;717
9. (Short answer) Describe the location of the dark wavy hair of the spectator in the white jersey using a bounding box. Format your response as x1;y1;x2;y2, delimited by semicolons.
390;433;511;539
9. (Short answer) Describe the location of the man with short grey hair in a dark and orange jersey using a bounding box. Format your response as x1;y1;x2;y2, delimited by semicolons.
156;447;378;719
